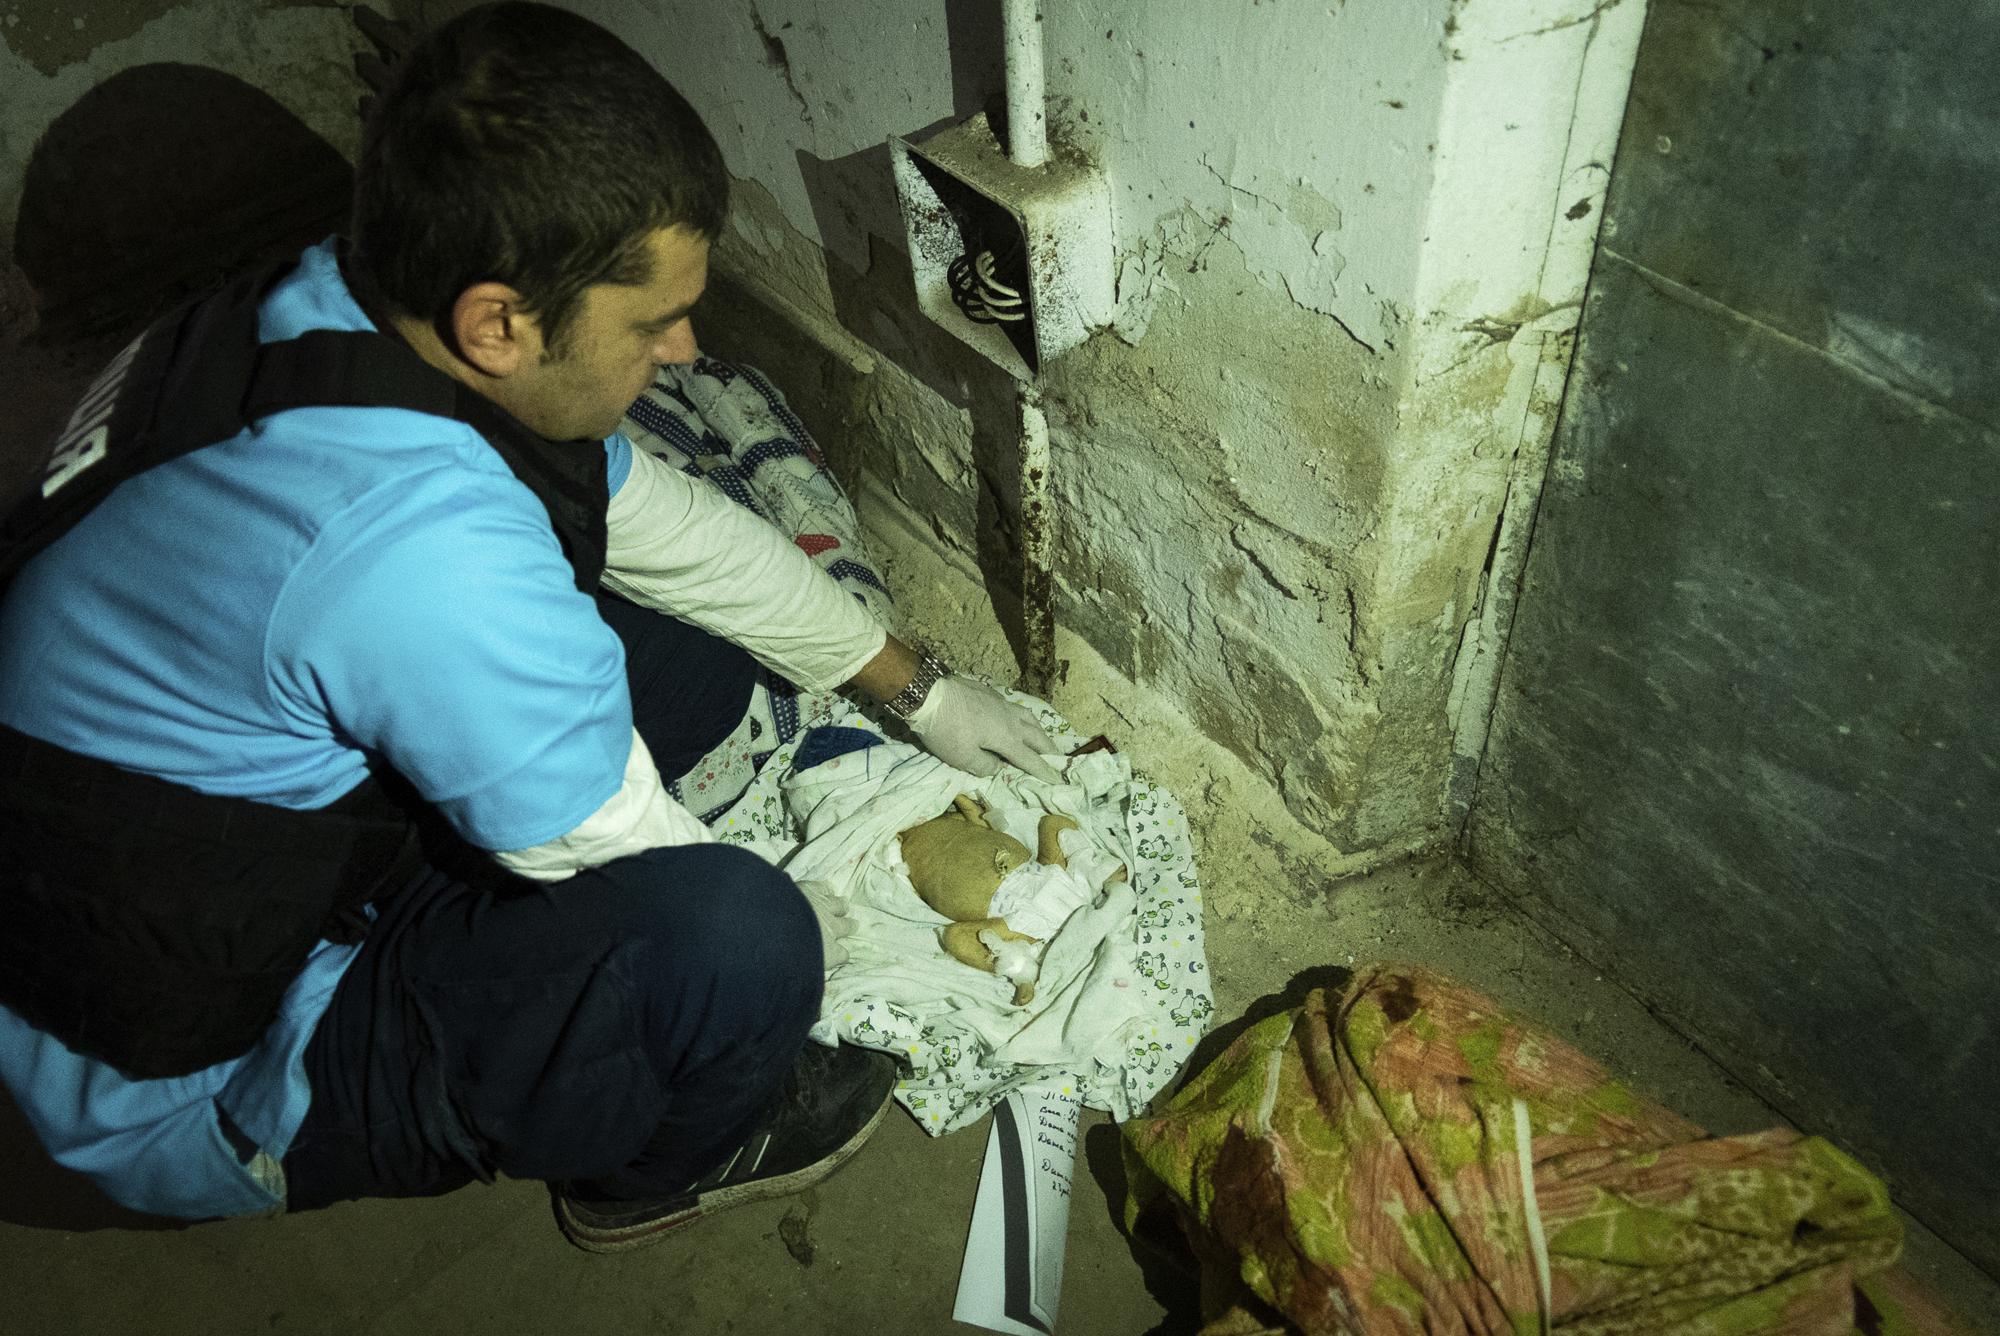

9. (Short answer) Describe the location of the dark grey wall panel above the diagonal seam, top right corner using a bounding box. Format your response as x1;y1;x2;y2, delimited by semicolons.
1610;0;2000;426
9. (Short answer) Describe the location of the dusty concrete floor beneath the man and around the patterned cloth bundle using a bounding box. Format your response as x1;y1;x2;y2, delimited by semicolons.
0;862;2000;1336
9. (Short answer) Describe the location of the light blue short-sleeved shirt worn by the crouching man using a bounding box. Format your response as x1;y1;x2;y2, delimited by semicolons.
0;235;632;1218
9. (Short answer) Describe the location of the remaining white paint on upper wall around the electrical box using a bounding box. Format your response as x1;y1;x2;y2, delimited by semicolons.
552;0;1452;348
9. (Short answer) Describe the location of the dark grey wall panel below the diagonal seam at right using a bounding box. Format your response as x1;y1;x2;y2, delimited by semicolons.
1474;253;2000;1260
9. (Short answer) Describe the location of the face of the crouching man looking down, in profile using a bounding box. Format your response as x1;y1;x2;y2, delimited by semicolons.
508;224;708;440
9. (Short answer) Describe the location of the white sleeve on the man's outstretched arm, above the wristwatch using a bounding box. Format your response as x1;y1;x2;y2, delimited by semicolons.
604;448;888;692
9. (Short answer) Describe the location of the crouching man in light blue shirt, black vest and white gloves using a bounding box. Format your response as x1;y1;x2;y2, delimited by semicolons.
0;4;1050;1250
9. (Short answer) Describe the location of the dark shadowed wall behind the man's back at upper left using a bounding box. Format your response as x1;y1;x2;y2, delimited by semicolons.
0;0;368;496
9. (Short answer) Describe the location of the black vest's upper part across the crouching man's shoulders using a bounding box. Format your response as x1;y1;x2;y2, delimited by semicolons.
0;266;610;594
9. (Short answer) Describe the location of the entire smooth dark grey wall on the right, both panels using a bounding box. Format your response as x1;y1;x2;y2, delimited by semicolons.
1470;0;2000;1272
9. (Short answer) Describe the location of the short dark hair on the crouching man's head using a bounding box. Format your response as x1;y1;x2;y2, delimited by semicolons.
350;4;730;352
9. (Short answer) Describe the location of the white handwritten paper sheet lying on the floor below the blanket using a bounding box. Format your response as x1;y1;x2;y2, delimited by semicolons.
952;1082;1082;1336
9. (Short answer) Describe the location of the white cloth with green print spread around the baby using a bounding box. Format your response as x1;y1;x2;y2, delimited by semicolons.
714;696;1214;1134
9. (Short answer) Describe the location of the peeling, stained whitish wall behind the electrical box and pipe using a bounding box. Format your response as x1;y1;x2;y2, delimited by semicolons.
460;0;1642;860
